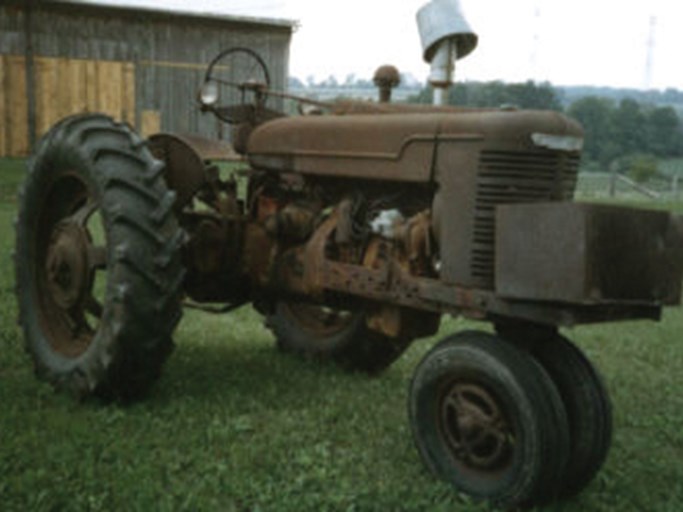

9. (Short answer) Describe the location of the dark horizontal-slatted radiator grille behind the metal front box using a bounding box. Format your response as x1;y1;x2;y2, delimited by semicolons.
470;151;580;288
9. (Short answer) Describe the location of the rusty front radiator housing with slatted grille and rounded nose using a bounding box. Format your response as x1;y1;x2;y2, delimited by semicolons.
432;112;583;289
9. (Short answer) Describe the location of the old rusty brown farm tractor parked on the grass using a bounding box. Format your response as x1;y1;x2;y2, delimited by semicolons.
15;3;683;508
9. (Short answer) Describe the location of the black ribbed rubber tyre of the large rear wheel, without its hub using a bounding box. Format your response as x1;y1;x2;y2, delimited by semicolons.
16;114;184;401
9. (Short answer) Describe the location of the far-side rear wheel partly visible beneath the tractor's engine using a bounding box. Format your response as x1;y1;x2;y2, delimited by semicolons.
268;301;410;373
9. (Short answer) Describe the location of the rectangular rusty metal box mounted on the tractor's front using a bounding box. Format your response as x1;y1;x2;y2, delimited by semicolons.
496;203;683;304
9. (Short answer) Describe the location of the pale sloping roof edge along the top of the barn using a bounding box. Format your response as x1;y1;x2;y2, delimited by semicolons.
39;0;298;30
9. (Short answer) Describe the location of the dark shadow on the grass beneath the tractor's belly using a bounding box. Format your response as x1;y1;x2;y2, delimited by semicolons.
147;328;408;411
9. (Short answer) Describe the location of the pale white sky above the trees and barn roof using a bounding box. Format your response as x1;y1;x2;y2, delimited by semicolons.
101;0;683;89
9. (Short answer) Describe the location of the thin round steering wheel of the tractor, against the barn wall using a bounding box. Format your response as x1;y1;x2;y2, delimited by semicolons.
199;47;270;124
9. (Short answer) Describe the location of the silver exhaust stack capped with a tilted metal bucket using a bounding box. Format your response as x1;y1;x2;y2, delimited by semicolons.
417;0;477;105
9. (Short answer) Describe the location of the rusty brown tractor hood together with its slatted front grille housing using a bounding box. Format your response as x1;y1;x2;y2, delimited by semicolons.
250;111;583;298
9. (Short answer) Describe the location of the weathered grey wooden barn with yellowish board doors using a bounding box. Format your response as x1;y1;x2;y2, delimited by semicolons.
0;0;295;156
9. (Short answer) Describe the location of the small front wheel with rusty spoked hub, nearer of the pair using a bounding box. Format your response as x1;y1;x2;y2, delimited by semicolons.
409;331;569;508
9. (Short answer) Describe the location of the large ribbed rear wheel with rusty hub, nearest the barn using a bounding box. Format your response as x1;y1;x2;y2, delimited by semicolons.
15;115;183;400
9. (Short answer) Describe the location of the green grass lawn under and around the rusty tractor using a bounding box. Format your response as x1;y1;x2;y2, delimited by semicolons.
0;160;683;512
